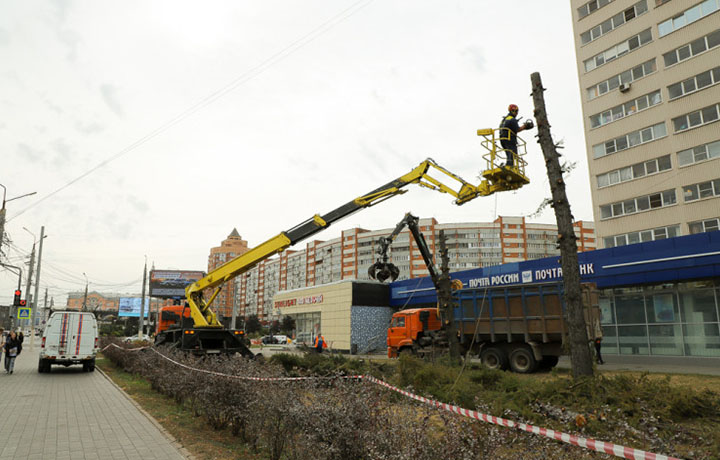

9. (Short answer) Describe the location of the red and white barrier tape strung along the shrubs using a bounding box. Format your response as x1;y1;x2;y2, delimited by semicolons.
101;343;680;460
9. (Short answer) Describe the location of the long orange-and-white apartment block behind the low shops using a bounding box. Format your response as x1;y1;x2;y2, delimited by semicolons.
235;217;596;321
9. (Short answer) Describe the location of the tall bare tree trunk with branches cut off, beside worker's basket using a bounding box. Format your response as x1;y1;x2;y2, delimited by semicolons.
530;72;593;377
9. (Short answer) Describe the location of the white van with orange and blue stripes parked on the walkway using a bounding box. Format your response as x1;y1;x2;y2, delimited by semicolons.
38;311;98;372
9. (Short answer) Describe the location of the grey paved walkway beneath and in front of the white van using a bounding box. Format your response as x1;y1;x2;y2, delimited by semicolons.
0;346;185;460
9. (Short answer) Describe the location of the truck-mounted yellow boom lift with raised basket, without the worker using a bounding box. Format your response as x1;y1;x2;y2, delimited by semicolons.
155;129;530;357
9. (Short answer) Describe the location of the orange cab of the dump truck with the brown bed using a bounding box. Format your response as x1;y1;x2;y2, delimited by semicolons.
387;308;442;358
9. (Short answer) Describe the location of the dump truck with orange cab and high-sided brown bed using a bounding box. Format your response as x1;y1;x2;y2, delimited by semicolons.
387;282;599;373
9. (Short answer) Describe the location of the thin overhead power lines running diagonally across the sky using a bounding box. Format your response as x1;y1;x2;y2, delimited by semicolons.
6;0;373;222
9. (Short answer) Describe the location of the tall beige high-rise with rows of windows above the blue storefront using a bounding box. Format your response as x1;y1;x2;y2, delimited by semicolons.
570;0;720;247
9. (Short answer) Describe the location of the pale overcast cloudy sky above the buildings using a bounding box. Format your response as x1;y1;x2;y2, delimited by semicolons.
0;0;592;304
